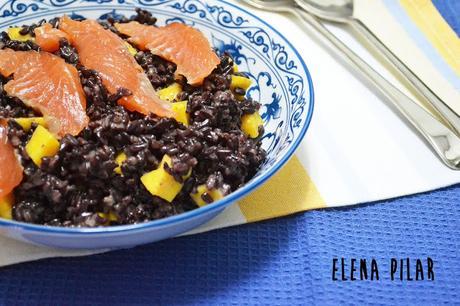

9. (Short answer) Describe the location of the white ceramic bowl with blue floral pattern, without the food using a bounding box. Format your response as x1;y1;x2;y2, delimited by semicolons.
0;0;313;248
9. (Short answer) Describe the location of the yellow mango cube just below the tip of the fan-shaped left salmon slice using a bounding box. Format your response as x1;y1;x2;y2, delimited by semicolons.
26;125;59;166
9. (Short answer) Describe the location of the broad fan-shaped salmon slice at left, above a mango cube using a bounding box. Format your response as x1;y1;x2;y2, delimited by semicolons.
0;49;89;137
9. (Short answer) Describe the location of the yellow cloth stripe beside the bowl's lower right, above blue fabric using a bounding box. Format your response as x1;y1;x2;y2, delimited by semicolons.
238;156;326;222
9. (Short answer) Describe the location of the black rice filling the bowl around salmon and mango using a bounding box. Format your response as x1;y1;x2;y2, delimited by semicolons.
0;10;266;227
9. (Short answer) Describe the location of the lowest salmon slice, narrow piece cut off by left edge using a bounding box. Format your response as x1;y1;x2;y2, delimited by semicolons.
0;125;22;198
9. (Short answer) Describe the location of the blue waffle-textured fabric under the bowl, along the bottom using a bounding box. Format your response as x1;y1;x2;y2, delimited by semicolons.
0;185;460;305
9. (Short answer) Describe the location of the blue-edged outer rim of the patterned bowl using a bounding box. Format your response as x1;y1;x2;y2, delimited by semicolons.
0;0;314;236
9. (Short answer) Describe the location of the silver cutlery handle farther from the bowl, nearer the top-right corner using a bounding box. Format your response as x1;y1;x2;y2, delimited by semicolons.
349;18;460;135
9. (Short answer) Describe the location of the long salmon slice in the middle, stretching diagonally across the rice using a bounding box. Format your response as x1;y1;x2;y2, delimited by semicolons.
59;16;173;117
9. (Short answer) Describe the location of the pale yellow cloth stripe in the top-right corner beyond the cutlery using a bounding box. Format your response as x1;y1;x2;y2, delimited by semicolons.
400;0;460;76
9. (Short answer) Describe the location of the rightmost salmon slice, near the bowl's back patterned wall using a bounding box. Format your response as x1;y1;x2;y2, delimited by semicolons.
115;21;220;85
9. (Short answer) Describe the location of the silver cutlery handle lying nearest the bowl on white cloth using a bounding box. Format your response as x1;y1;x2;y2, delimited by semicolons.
292;10;460;170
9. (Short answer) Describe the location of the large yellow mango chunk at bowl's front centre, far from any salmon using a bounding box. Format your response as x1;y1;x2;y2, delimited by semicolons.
141;154;183;202
